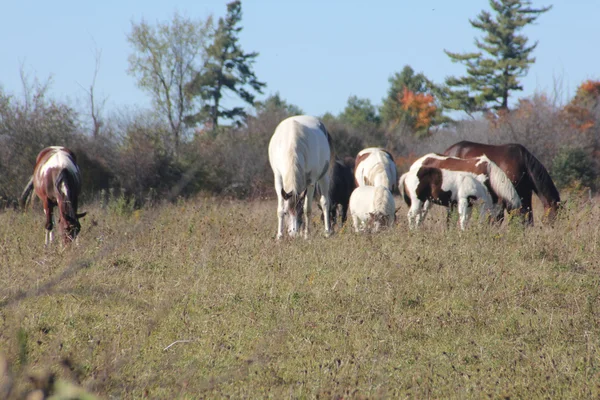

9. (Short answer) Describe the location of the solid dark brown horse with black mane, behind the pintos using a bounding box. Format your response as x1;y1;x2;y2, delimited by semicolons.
444;141;560;225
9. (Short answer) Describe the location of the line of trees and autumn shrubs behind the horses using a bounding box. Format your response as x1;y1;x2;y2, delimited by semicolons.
0;0;600;204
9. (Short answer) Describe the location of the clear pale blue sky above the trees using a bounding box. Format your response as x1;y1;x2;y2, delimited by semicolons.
0;0;600;116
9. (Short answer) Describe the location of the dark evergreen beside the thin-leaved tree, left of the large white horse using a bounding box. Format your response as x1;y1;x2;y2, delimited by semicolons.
188;0;265;130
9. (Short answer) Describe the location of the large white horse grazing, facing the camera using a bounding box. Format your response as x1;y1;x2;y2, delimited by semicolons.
269;115;334;239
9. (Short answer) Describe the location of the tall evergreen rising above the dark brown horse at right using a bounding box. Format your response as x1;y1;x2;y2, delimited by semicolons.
443;0;552;115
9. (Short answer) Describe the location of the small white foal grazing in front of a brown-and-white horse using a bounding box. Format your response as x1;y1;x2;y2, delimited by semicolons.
350;185;396;232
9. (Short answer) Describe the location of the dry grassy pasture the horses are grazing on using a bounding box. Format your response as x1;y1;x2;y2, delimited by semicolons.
0;194;600;399
